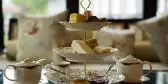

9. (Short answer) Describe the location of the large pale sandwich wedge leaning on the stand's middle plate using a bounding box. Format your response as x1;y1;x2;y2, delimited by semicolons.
71;40;94;54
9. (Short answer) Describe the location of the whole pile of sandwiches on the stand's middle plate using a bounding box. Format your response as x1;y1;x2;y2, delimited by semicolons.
63;39;111;54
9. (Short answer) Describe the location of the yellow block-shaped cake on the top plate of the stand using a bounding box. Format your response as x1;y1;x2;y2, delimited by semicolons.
69;13;87;23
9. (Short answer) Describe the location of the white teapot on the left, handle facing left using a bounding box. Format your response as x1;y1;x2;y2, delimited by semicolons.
4;58;45;84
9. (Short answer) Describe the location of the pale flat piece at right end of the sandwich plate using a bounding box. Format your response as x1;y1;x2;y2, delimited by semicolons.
93;46;111;54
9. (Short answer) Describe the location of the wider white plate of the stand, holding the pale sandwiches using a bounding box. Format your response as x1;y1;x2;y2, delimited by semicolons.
53;48;118;62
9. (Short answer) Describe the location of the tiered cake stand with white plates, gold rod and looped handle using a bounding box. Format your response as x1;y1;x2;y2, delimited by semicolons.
53;0;117;78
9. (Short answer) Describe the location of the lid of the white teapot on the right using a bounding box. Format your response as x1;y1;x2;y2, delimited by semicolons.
119;55;142;63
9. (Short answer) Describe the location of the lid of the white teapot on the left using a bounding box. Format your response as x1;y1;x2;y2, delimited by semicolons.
15;58;39;67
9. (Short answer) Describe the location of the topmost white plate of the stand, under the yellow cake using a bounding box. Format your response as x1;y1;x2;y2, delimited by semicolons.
59;22;110;30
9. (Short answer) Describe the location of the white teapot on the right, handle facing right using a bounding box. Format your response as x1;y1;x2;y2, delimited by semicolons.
116;55;152;82
